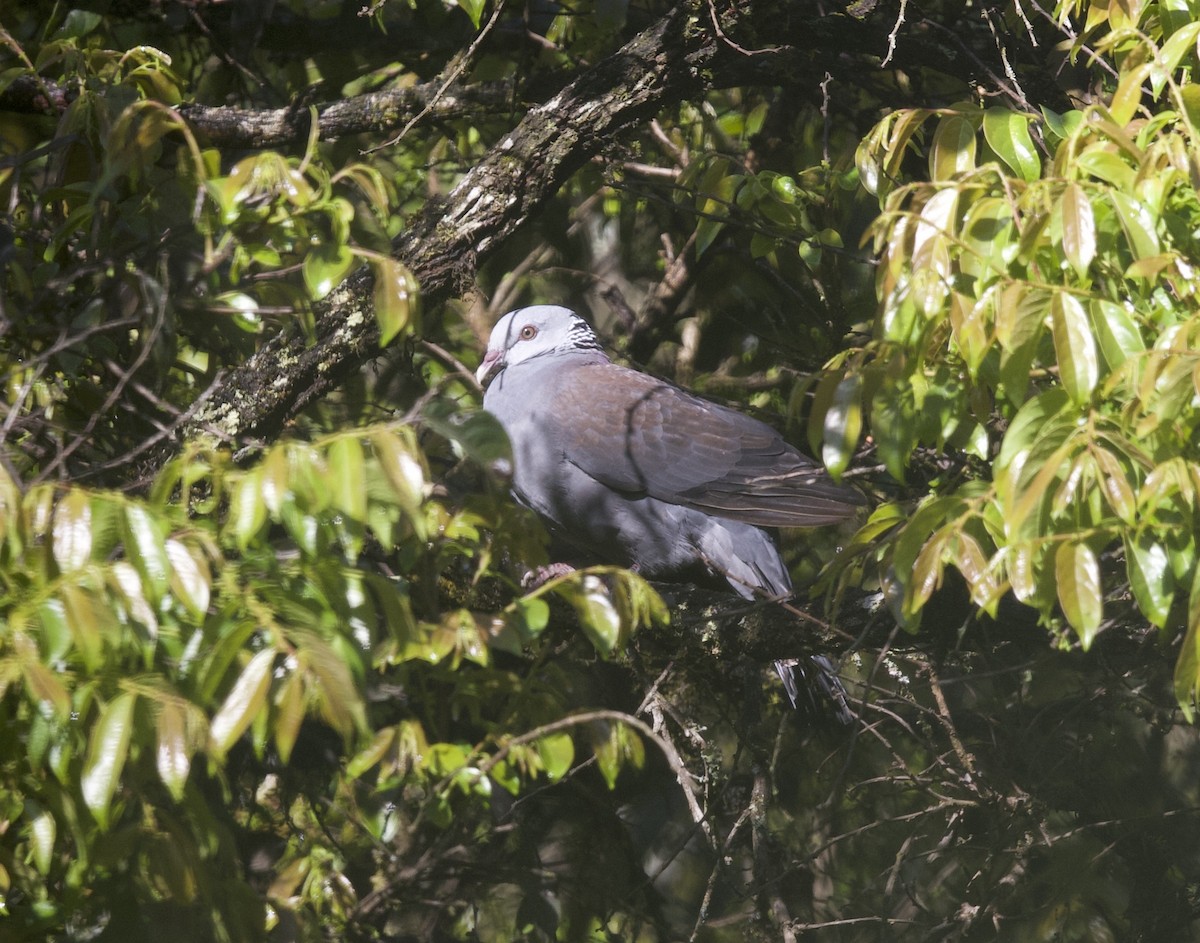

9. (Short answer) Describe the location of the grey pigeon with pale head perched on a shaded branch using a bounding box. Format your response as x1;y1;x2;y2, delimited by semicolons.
476;305;864;722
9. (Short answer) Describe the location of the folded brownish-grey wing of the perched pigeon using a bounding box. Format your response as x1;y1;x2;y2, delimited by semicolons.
546;362;863;527
